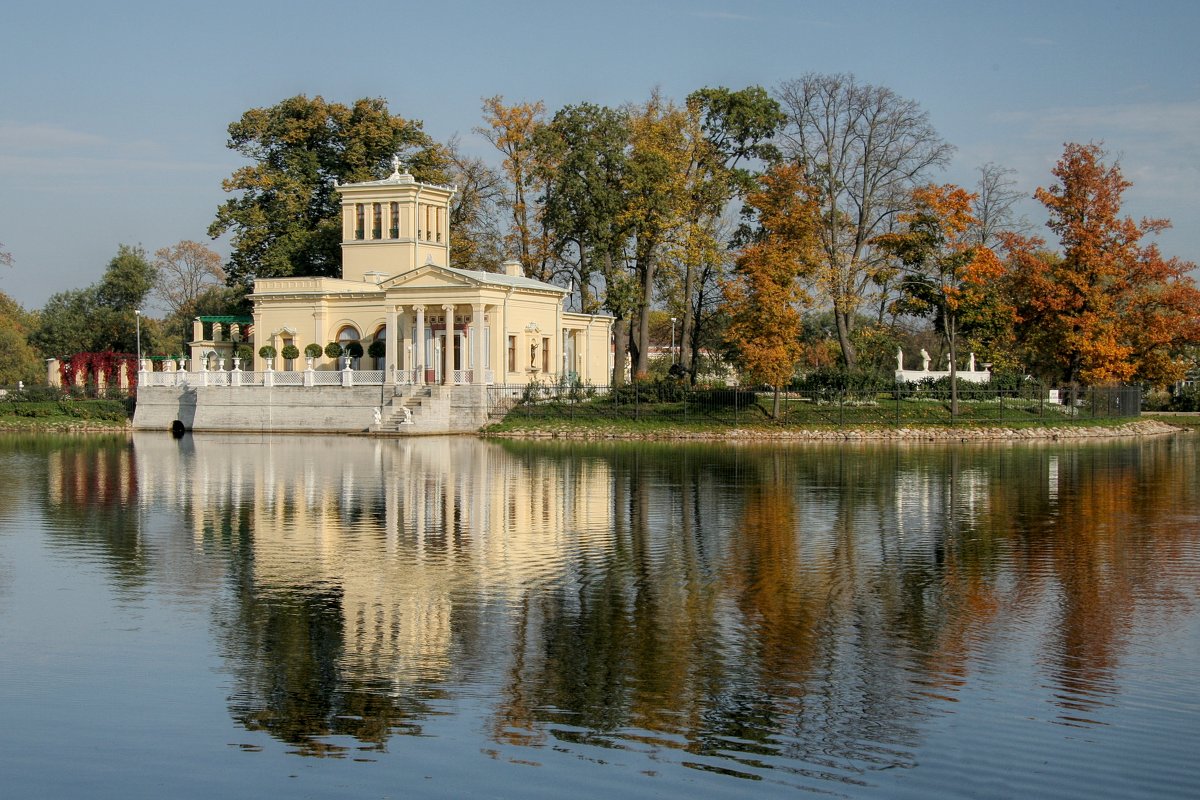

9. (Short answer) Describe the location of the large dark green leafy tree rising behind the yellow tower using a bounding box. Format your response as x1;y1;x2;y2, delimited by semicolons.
209;95;446;288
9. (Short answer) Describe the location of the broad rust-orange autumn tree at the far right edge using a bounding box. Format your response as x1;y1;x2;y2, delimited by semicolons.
1004;144;1200;385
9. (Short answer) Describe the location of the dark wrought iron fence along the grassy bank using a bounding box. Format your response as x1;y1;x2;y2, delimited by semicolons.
488;380;1141;427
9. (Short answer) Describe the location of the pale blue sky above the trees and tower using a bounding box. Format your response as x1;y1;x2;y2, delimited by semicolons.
0;0;1200;308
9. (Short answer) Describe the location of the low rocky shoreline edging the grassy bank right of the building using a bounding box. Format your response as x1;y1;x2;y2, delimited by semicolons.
484;420;1188;443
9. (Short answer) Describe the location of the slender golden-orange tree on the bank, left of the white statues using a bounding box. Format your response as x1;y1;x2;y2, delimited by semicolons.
724;163;821;419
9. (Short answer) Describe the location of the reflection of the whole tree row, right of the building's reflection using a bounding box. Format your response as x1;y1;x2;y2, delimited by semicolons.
489;440;1195;760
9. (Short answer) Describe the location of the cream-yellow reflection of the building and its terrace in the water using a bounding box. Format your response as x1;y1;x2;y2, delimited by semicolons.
134;435;613;684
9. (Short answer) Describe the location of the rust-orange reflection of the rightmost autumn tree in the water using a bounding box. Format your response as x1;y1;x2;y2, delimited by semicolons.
1009;438;1198;718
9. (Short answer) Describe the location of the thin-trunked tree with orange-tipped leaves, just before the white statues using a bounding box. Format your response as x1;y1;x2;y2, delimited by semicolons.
872;184;1004;414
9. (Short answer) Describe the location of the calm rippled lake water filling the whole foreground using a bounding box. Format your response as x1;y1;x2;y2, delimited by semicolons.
0;434;1200;800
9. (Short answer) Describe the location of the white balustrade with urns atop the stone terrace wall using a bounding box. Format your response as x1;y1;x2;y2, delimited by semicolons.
138;367;494;387
